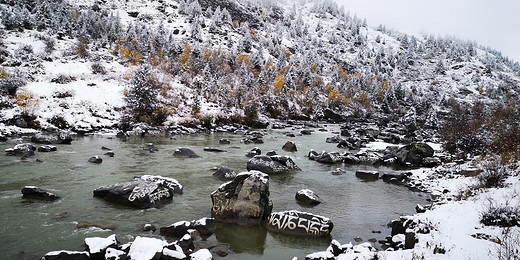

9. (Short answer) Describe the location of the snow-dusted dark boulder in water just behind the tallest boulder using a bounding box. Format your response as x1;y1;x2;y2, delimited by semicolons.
247;155;300;174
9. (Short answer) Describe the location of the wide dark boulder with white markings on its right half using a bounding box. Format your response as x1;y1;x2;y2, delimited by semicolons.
94;175;182;208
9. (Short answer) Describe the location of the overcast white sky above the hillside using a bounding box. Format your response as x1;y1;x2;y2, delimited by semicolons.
334;0;520;62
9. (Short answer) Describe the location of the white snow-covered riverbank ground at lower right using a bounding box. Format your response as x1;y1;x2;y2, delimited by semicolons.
310;151;520;260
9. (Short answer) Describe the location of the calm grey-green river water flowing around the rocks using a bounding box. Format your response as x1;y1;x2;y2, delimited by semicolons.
0;125;428;259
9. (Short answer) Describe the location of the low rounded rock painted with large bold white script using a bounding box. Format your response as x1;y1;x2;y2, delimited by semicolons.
266;210;334;237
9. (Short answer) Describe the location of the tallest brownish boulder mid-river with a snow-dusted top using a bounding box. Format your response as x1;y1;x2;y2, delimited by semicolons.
211;171;273;225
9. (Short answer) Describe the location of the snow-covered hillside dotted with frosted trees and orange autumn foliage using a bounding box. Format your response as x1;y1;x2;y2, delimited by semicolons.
0;0;520;134
